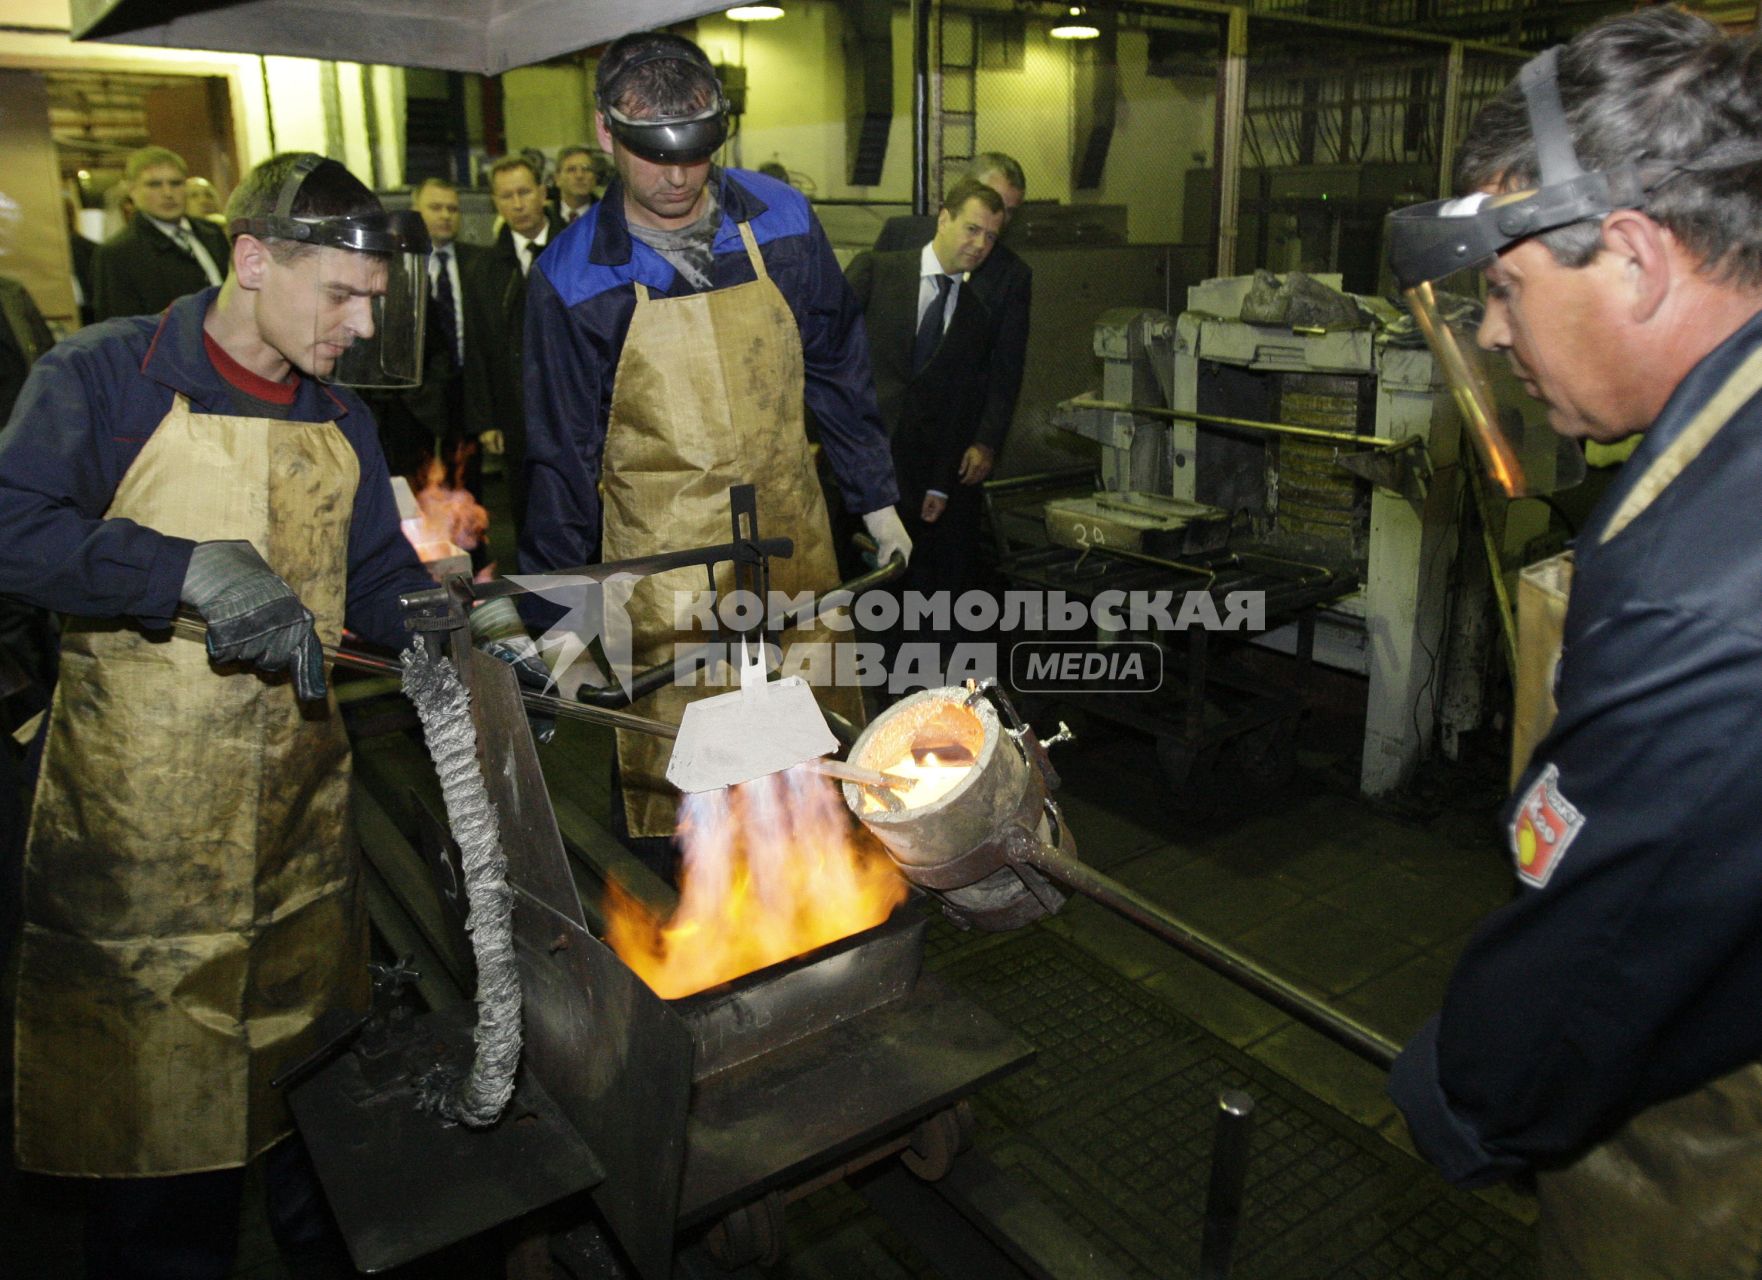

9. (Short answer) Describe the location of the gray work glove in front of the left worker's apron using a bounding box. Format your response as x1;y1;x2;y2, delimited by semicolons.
178;541;326;702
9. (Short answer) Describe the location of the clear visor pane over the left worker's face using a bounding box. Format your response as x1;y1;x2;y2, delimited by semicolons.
308;247;428;388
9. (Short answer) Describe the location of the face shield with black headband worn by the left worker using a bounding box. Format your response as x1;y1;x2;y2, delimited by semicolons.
229;155;430;388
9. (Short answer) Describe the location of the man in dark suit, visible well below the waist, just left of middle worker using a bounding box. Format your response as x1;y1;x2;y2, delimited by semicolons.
465;155;562;560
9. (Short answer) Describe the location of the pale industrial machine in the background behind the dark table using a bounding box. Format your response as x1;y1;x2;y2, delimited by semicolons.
1036;275;1522;795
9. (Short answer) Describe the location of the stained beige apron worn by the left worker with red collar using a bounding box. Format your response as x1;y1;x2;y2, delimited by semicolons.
16;395;366;1176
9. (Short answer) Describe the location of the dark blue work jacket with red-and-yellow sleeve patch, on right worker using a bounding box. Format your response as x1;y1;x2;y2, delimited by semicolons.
1390;316;1762;1187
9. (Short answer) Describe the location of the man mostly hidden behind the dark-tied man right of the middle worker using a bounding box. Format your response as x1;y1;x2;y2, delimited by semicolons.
876;152;1034;485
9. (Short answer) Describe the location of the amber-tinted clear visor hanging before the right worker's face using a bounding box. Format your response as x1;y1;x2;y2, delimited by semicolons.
1403;270;1584;497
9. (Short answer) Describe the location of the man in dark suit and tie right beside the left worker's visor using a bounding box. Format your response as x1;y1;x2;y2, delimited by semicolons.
366;178;486;486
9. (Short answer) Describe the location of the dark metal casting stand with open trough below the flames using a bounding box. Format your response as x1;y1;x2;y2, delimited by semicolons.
278;500;1112;1280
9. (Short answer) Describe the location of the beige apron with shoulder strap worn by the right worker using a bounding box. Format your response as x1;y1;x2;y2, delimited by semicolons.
1536;351;1762;1280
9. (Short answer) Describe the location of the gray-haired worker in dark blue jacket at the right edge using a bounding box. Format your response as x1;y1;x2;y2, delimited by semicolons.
1390;9;1762;1280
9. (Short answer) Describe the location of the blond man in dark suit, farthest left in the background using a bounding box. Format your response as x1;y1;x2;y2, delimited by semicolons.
92;146;231;321
